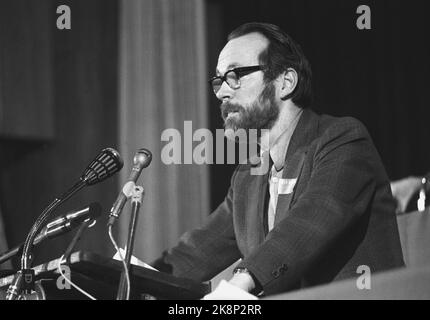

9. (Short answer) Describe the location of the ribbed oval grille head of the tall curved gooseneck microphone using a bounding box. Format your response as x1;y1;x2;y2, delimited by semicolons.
81;148;124;186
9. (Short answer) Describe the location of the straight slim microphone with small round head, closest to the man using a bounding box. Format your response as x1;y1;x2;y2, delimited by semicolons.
108;148;152;226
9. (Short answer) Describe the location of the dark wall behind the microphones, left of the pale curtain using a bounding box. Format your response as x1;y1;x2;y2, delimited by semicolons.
0;0;118;263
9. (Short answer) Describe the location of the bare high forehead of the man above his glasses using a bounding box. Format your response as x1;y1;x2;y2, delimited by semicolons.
217;32;269;73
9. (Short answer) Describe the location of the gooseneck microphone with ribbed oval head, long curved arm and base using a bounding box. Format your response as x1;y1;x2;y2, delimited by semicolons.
6;148;123;300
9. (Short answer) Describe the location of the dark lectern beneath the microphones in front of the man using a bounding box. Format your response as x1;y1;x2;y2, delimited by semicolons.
0;251;210;300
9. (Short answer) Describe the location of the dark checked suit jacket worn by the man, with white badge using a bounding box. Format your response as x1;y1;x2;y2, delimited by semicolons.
154;110;404;294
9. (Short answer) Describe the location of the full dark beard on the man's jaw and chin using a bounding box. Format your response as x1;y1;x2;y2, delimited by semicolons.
221;83;279;131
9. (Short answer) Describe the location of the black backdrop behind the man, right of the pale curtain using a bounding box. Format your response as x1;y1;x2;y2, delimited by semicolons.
207;0;430;208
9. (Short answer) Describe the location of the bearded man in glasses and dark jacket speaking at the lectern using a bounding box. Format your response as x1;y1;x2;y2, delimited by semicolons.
153;23;404;299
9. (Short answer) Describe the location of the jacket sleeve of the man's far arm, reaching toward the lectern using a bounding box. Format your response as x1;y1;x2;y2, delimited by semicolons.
151;172;240;281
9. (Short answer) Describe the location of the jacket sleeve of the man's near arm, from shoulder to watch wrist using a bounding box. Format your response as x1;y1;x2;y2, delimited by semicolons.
240;119;379;294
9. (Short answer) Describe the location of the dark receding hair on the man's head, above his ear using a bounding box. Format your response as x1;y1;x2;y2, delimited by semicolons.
228;22;313;108
